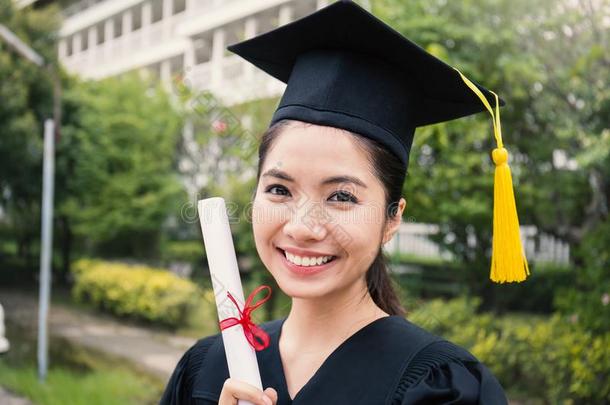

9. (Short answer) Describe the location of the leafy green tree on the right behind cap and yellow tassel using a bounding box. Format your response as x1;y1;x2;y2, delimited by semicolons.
373;0;610;303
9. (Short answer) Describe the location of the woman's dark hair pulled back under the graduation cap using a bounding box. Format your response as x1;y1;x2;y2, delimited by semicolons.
256;120;406;316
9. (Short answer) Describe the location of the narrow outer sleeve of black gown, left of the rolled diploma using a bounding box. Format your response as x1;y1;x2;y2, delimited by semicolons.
159;334;220;405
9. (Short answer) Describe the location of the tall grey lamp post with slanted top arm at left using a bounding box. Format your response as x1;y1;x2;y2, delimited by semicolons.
0;24;61;381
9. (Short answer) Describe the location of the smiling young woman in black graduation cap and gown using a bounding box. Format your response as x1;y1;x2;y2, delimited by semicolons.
161;1;506;405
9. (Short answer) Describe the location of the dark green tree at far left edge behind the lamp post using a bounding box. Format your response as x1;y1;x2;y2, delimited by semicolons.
0;0;59;267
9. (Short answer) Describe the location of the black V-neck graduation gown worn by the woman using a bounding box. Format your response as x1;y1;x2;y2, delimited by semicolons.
161;315;507;405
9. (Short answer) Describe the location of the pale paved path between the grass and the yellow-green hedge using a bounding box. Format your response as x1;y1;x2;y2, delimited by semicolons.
0;290;195;378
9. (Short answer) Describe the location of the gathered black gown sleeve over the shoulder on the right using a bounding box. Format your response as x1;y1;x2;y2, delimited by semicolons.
392;340;508;405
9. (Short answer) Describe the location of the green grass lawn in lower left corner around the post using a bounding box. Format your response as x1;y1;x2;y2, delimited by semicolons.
0;324;163;405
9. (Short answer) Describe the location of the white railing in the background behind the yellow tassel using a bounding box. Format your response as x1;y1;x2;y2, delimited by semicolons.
384;223;570;265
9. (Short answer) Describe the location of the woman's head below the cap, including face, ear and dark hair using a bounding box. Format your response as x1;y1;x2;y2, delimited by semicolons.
253;120;406;315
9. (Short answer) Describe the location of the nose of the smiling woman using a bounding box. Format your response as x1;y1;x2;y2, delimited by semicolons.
283;202;331;242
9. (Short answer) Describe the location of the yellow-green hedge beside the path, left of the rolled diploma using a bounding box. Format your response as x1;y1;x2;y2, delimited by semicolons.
72;259;201;326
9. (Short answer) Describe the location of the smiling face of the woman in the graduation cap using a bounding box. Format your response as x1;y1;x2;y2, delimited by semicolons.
252;123;400;298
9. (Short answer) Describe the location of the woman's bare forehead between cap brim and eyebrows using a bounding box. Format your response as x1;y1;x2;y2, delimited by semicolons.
263;123;371;177
